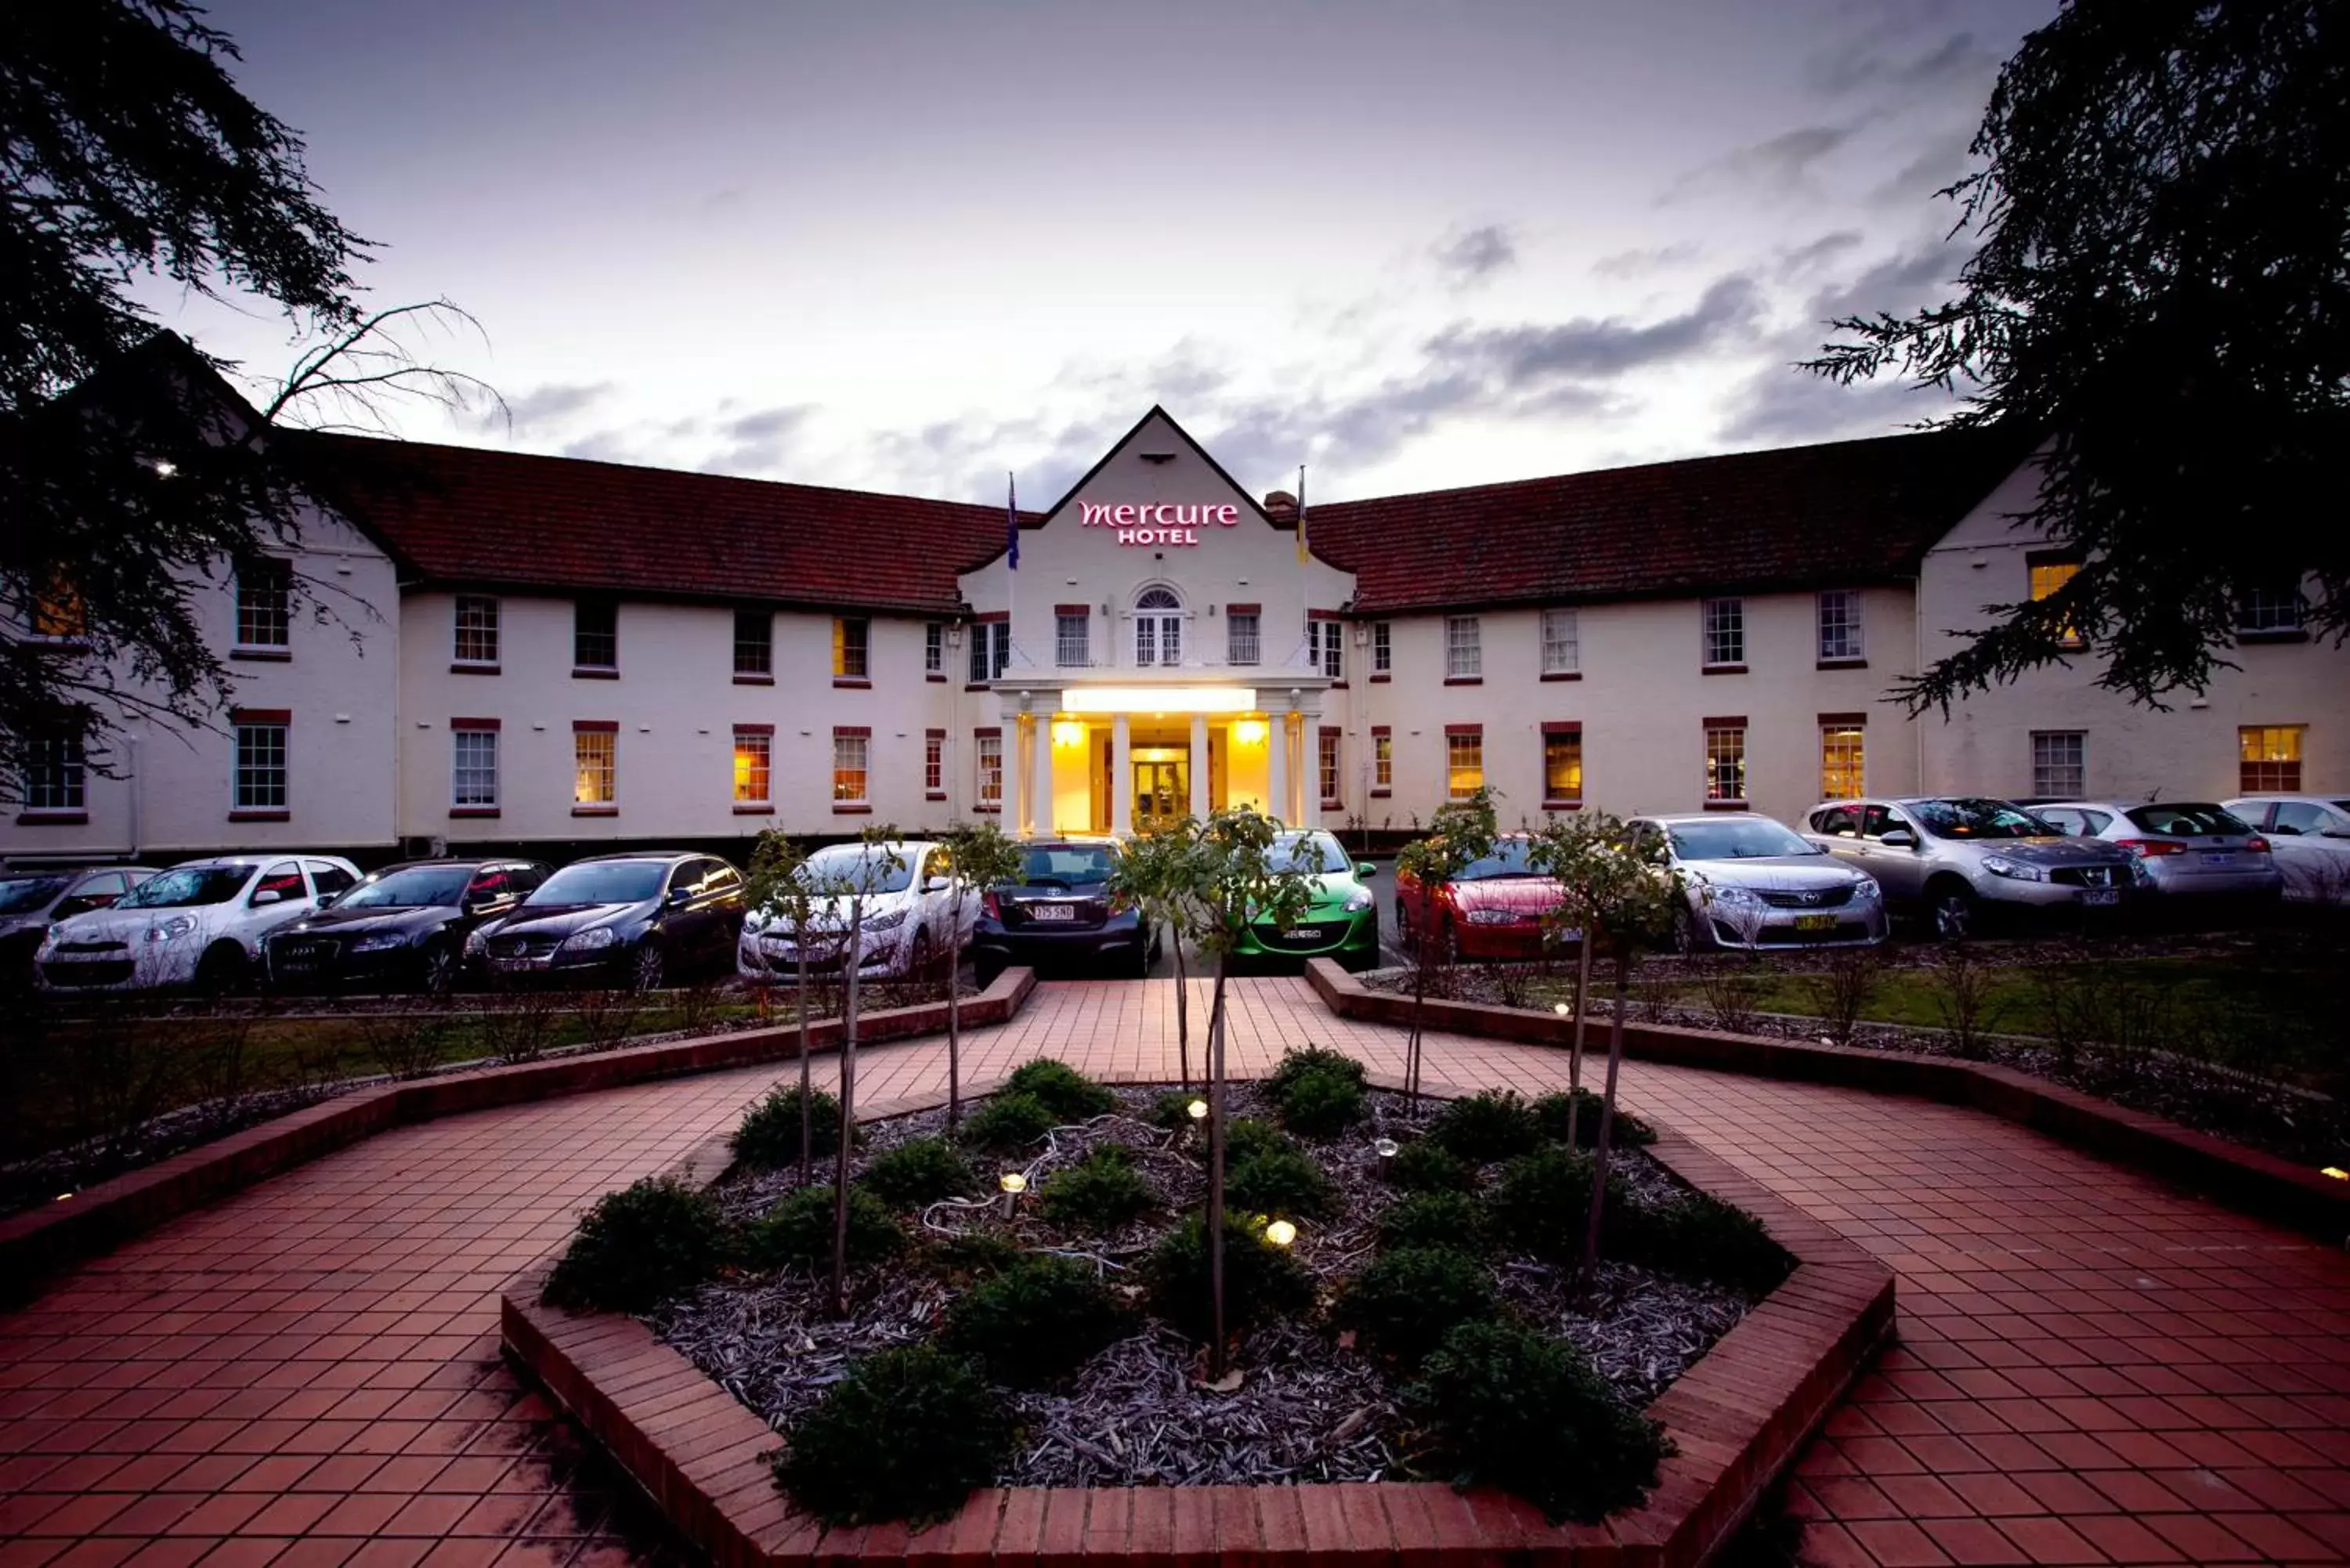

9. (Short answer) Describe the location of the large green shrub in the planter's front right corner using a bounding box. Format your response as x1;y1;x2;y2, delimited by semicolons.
1403;1321;1671;1523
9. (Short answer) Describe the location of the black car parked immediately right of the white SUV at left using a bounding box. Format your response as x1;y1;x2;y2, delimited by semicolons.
261;861;548;995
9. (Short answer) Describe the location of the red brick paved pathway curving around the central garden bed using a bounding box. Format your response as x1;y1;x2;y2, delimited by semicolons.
0;981;2350;1568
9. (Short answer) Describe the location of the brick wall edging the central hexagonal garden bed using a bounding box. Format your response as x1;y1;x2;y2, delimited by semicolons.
501;1084;1894;1568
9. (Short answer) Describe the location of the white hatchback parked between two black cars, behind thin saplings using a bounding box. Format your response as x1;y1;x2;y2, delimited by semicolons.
736;840;980;985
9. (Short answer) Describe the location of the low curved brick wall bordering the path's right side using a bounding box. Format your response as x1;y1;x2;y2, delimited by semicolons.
1307;959;2350;1241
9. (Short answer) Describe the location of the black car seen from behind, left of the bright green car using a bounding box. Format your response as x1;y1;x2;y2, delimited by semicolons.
971;840;1159;985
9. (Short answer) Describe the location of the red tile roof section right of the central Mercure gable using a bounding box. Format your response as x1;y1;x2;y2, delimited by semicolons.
1307;430;2030;613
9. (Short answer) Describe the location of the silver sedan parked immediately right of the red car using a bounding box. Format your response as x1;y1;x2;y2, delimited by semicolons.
1626;811;1892;952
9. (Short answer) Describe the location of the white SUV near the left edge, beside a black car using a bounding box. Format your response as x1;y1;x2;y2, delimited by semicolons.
33;856;360;992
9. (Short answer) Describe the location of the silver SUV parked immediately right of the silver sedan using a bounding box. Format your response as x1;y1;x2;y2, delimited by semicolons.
1805;795;2148;938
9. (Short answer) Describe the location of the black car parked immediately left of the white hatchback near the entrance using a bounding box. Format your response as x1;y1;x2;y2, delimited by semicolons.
465;851;743;990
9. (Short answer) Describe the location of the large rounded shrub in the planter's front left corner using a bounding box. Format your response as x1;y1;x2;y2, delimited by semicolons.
773;1345;1013;1528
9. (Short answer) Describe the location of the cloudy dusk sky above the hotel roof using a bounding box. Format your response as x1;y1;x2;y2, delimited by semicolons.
160;0;2056;505
